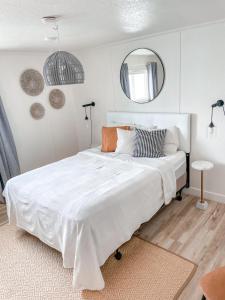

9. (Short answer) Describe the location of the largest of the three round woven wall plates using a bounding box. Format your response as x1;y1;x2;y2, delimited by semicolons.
20;69;44;96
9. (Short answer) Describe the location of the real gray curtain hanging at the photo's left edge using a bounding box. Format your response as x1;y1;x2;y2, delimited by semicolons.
0;98;20;201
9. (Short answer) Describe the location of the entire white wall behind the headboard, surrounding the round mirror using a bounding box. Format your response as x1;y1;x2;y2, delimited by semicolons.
76;23;225;202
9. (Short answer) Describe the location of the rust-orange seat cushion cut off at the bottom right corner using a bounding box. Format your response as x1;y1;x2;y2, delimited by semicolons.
200;267;225;300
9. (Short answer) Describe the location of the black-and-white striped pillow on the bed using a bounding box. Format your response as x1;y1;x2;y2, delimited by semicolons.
133;128;166;157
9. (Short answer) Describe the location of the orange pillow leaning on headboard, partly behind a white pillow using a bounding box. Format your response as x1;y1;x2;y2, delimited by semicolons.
101;126;130;152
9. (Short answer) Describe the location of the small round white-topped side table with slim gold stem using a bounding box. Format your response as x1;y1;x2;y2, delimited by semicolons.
191;160;214;210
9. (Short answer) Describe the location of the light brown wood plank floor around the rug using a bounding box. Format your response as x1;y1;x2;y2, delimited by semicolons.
0;196;225;300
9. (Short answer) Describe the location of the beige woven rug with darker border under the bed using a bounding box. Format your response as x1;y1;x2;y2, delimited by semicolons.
0;224;196;300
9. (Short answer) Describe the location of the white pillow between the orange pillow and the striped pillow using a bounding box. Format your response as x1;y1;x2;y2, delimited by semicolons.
116;128;135;155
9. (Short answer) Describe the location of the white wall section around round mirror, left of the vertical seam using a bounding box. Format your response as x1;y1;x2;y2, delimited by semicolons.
77;33;180;149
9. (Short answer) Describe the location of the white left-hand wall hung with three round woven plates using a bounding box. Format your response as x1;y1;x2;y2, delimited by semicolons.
0;52;78;171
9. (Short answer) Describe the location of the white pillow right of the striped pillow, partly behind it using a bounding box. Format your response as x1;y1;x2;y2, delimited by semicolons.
163;126;179;155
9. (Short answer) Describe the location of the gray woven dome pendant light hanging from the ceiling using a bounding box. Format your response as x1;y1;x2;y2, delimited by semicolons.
43;17;84;86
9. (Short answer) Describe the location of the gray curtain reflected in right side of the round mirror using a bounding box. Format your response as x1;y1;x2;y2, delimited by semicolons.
147;62;158;100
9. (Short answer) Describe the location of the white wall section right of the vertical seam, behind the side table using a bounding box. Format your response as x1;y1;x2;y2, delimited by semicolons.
181;24;225;202
